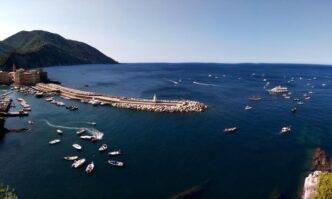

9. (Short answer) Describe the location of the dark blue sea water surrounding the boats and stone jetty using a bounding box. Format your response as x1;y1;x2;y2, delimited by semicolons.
0;64;332;199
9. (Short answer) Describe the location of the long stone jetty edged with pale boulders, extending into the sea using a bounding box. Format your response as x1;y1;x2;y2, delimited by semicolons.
32;83;207;113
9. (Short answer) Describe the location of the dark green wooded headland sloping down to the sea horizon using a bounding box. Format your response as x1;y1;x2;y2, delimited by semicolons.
0;30;118;71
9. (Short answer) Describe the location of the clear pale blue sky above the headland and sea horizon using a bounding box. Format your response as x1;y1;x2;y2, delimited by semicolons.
0;0;332;64
